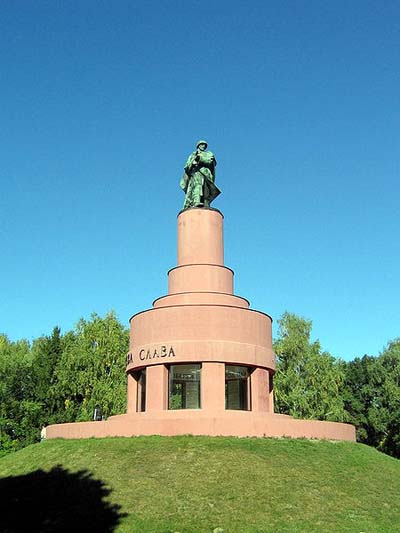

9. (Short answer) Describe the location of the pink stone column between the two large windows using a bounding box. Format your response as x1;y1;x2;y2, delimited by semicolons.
201;363;225;412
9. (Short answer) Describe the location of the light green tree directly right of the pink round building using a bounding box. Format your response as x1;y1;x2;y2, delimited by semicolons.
274;313;346;422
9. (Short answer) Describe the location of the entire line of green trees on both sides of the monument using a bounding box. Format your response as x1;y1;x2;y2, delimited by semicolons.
0;312;400;458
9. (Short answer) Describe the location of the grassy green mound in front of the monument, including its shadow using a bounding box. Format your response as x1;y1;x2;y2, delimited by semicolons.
0;436;400;533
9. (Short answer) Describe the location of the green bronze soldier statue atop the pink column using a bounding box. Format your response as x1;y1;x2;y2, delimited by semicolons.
179;141;221;210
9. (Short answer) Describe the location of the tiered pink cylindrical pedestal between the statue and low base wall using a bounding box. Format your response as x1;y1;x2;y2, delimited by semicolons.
127;208;275;424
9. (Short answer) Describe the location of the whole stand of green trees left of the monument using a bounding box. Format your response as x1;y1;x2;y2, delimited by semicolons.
0;313;129;455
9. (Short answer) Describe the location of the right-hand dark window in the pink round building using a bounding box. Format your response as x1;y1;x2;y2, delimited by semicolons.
225;365;250;411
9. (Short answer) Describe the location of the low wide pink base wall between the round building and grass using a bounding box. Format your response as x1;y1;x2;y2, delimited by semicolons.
45;409;356;442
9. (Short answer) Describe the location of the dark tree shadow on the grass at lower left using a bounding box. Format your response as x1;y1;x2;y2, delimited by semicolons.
0;466;125;533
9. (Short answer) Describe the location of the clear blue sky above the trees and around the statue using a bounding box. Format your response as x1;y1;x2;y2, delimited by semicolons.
0;0;400;359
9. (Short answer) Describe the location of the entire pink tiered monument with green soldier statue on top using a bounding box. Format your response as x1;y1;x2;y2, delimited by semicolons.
46;141;355;441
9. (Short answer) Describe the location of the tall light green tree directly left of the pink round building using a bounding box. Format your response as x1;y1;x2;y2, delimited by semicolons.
49;313;129;422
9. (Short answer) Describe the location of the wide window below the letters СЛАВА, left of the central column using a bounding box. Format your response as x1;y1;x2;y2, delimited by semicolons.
168;365;201;409
